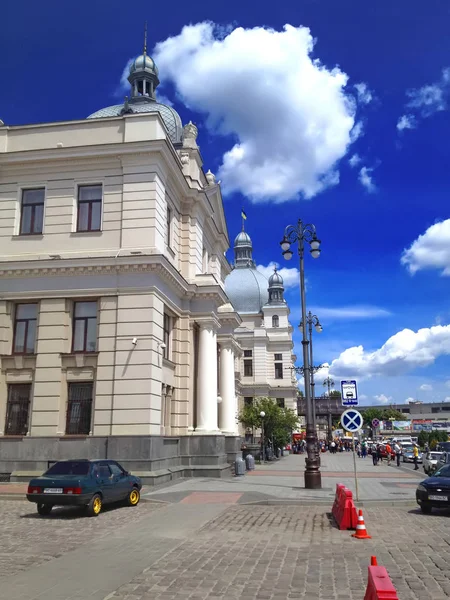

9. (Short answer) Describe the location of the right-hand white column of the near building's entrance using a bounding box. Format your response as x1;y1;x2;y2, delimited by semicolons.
219;342;237;435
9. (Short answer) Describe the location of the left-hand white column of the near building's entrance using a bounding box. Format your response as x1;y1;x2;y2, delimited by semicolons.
196;321;219;434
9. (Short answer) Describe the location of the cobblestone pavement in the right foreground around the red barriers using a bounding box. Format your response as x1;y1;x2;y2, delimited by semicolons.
106;505;450;600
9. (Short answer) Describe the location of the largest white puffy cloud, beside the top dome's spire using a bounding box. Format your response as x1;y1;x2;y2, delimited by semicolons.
154;22;358;202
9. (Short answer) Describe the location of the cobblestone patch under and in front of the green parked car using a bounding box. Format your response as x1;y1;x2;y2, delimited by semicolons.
0;500;161;580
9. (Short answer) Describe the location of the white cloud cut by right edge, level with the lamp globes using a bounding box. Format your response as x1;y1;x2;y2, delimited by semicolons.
401;219;450;276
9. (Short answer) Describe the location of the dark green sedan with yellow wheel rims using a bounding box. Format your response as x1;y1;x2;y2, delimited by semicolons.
27;460;142;517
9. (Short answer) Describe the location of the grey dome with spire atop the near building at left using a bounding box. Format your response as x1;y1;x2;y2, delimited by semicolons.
87;27;183;144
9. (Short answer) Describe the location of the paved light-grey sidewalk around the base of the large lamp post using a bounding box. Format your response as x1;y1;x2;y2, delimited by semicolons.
143;453;424;505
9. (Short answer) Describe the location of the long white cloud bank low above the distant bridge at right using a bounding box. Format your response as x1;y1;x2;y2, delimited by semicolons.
330;325;450;378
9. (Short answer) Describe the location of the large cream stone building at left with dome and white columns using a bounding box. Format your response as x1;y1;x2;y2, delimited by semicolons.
0;43;241;482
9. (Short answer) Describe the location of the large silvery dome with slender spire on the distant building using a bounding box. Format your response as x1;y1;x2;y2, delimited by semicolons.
225;229;269;314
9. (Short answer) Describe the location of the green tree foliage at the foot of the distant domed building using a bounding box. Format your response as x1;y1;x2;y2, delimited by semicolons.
238;398;299;448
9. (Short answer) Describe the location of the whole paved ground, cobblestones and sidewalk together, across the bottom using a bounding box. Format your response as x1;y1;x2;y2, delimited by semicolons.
0;454;450;600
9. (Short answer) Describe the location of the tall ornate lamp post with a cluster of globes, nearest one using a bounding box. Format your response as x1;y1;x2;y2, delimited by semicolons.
280;219;322;490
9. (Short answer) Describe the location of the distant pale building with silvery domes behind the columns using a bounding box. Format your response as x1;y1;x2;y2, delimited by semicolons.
225;229;297;433
